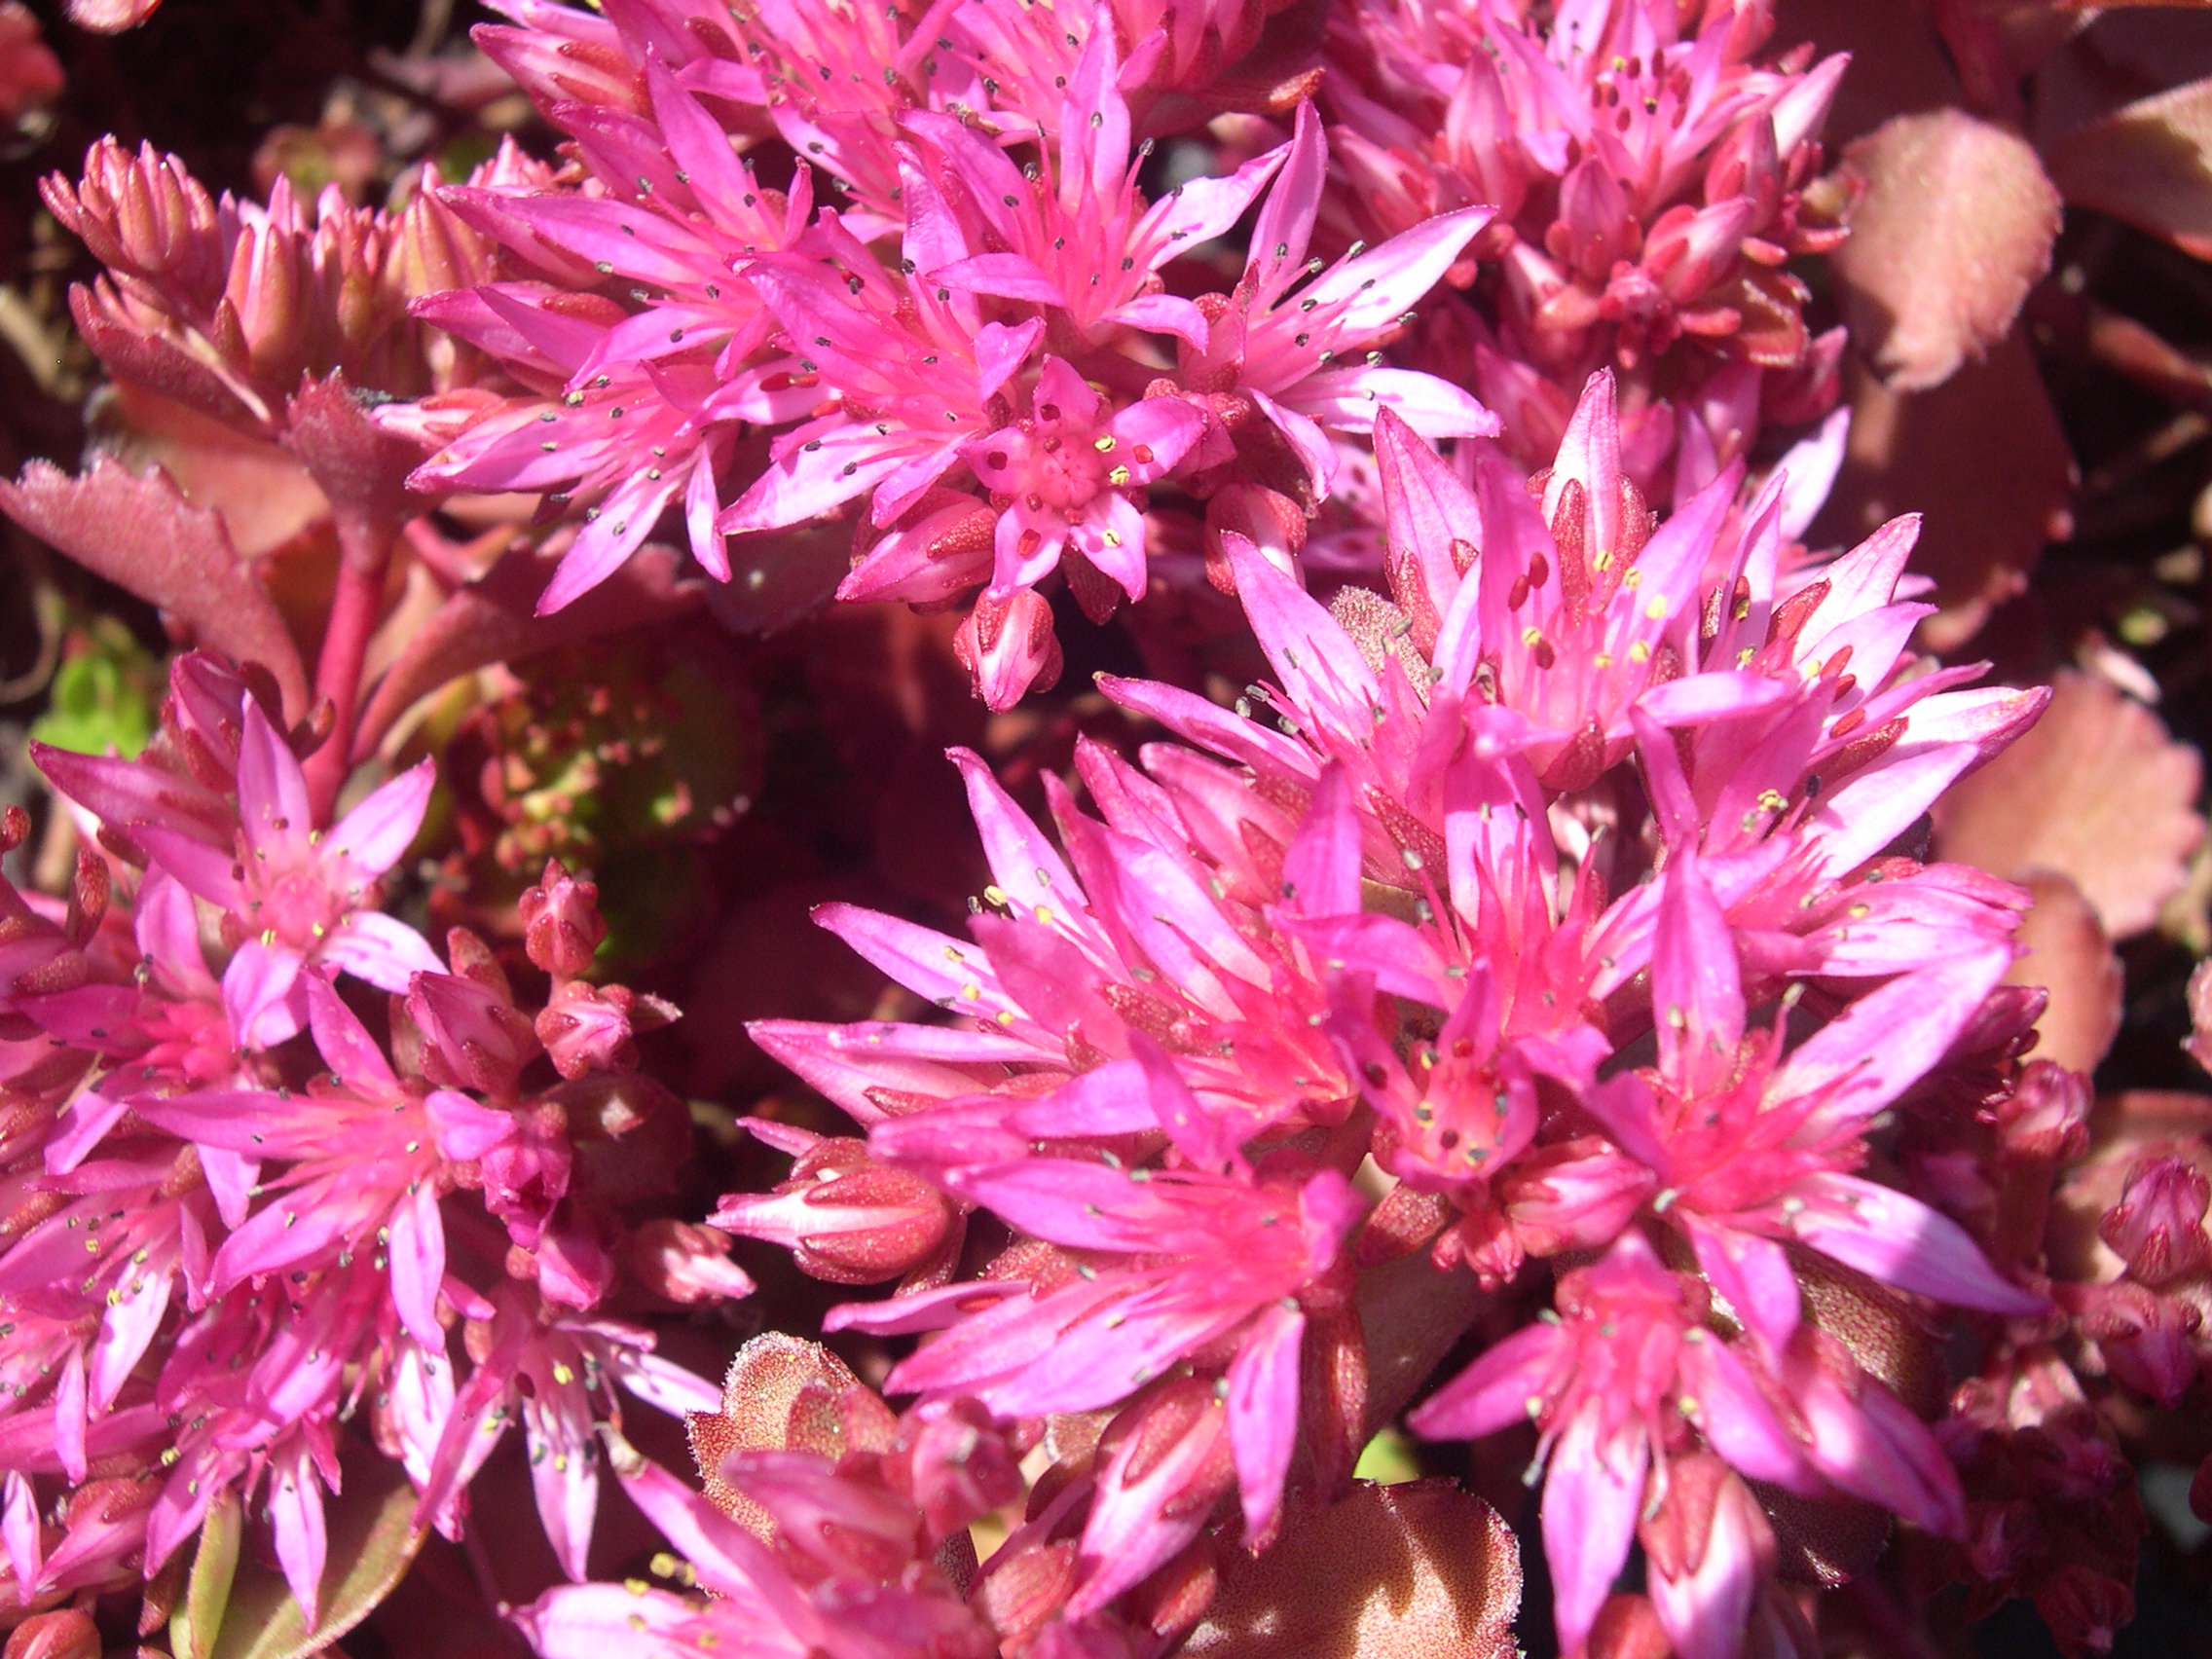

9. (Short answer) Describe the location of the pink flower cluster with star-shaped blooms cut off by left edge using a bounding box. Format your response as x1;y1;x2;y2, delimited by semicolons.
0;655;750;1630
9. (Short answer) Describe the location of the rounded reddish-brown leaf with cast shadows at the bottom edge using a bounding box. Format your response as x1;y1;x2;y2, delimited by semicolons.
1181;1480;1522;1659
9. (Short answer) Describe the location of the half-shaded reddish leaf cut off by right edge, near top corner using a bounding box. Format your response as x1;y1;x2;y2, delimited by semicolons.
2050;80;2212;259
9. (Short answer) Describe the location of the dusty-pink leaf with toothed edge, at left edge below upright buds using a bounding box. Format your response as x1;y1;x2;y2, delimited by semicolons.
0;456;308;719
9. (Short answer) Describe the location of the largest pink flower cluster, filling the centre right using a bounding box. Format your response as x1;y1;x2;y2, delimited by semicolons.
717;374;2044;1654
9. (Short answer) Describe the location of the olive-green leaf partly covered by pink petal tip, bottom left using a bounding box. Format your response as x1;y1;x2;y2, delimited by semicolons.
205;1456;423;1659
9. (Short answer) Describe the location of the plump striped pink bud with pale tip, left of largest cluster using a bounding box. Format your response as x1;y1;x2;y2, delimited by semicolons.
708;1139;958;1285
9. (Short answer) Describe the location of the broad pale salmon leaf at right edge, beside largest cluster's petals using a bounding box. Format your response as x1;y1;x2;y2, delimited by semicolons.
1936;673;2205;938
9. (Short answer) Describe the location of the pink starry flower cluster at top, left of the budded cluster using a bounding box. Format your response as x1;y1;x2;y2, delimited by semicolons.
405;0;1495;708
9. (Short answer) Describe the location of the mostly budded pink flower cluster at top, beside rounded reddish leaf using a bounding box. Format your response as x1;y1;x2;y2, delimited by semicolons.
1325;0;1847;499
